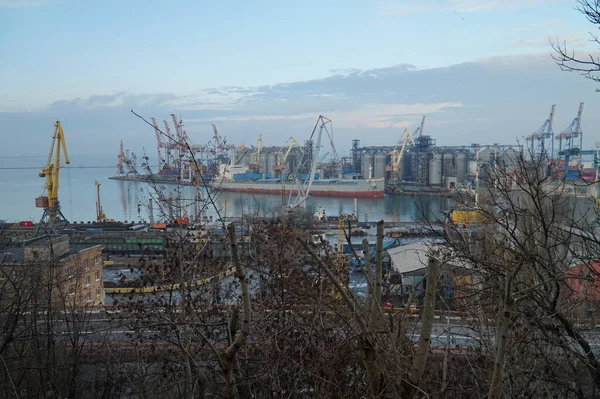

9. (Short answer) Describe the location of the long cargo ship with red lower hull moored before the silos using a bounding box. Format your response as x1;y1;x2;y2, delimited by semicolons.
211;165;385;198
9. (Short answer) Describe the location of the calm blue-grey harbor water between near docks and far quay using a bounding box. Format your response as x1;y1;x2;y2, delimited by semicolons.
0;156;450;222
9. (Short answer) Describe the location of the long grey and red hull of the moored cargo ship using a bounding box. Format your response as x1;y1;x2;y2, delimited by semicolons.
213;180;385;198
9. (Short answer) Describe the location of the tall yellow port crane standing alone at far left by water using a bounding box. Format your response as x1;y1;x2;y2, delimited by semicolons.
35;121;70;223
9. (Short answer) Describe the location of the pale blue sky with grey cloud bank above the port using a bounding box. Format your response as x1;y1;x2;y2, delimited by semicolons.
0;0;600;164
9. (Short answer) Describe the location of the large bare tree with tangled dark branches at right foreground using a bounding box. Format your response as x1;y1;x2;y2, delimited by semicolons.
447;148;600;398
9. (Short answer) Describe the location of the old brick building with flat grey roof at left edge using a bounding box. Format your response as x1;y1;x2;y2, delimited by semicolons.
0;235;104;309
